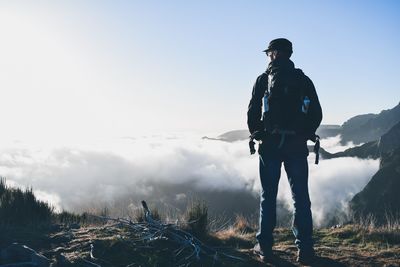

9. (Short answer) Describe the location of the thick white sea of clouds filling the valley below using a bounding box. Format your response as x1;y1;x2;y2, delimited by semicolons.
0;134;379;226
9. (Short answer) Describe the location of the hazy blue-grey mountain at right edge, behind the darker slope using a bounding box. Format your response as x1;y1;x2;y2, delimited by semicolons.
341;103;400;144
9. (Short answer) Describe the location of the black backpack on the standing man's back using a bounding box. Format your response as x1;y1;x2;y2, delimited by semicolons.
263;68;310;134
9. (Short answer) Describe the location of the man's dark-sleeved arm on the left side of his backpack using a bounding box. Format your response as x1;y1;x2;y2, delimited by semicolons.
247;73;268;134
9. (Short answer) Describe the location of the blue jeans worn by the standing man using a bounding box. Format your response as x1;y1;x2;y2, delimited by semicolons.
257;152;313;250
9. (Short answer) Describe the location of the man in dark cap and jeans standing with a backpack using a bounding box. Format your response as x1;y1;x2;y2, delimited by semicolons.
247;38;322;264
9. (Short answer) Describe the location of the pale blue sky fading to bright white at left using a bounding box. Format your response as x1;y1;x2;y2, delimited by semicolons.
0;0;400;142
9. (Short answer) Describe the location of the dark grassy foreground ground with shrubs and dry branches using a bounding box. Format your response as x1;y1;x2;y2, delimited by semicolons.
0;179;400;267
